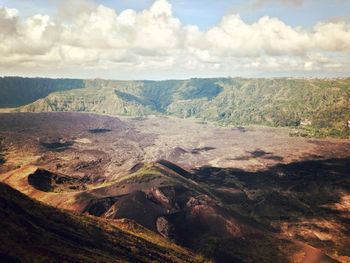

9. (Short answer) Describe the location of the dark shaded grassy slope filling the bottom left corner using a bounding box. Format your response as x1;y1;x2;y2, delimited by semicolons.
0;183;200;262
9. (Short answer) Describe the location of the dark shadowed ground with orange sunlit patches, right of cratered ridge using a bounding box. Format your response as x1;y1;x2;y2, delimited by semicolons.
192;158;350;256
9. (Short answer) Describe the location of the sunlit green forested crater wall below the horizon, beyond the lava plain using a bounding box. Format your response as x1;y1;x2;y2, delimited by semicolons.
4;78;350;137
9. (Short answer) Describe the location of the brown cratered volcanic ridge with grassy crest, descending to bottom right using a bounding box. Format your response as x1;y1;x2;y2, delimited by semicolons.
72;160;335;263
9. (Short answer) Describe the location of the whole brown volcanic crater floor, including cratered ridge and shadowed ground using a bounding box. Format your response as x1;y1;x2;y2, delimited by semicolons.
0;113;350;262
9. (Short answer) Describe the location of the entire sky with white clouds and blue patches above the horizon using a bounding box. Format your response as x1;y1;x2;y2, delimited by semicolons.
0;0;350;79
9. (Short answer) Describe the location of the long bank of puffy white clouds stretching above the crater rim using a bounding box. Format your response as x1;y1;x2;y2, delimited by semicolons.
0;0;350;78
